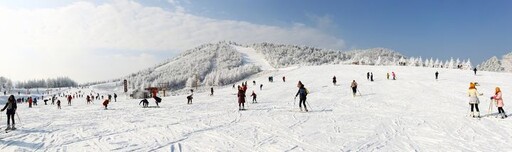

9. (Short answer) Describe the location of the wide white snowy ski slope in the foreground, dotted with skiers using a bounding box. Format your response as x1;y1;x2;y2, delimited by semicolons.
0;65;512;151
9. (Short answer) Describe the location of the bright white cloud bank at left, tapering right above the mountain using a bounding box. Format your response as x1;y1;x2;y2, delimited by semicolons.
0;0;345;82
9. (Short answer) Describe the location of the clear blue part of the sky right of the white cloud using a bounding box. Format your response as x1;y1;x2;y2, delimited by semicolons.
173;0;512;64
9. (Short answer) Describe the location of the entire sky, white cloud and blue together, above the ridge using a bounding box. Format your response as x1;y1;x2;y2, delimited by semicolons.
0;0;512;82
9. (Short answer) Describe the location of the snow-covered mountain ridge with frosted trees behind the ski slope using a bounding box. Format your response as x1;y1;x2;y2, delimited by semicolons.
117;41;471;90
